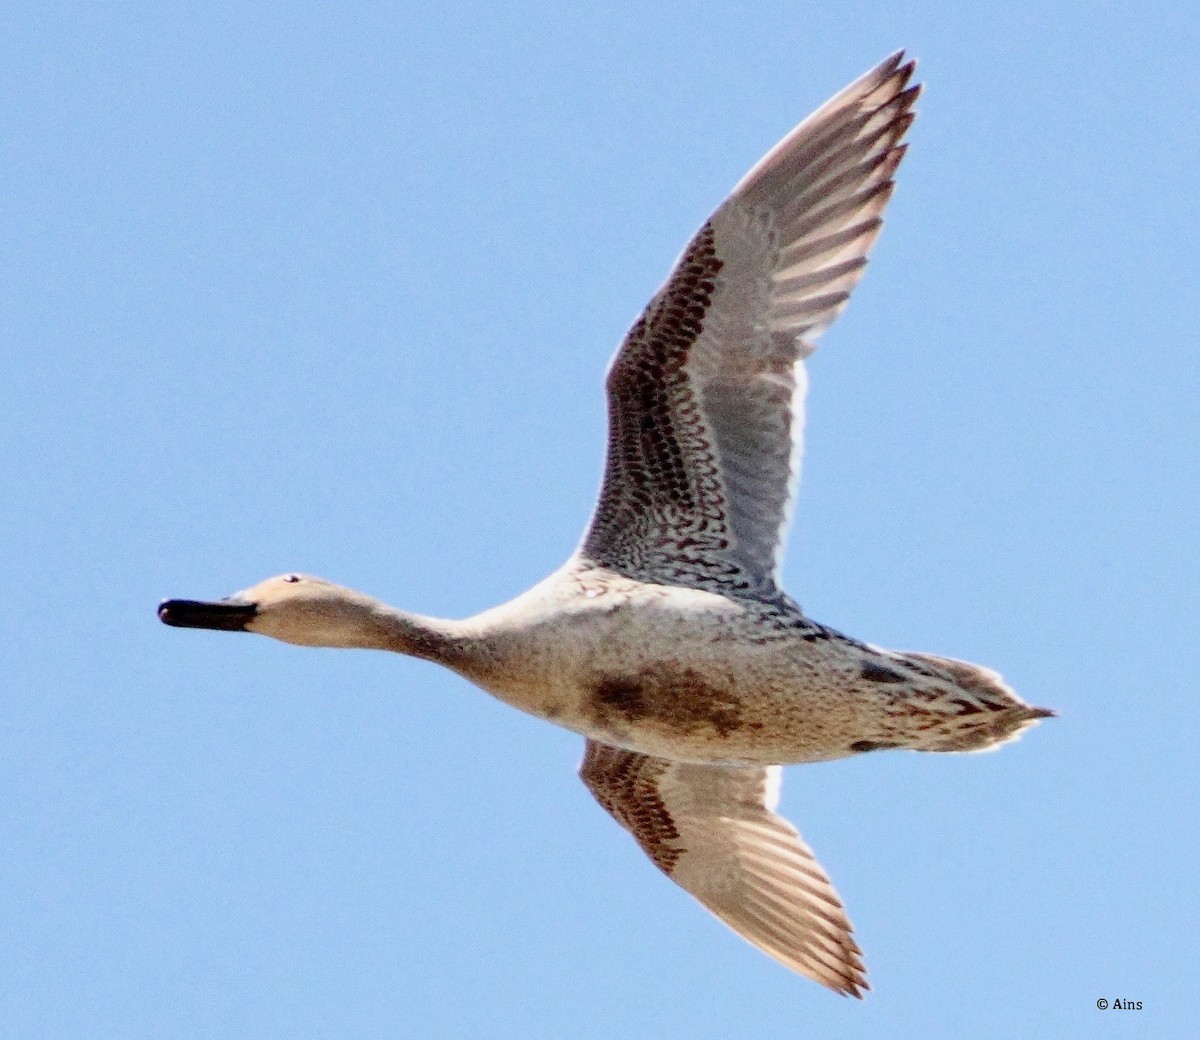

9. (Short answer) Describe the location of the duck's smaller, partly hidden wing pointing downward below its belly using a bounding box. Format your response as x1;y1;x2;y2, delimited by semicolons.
580;740;869;997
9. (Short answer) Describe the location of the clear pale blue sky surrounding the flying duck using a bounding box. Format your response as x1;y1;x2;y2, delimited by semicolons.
0;0;1200;1040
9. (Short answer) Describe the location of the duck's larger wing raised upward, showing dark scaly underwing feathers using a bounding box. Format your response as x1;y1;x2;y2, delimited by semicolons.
581;53;919;594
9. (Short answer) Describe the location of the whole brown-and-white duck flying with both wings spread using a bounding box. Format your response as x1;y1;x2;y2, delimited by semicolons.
158;50;1054;997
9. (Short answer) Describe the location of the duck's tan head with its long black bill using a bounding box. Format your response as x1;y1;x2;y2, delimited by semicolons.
158;575;378;647
